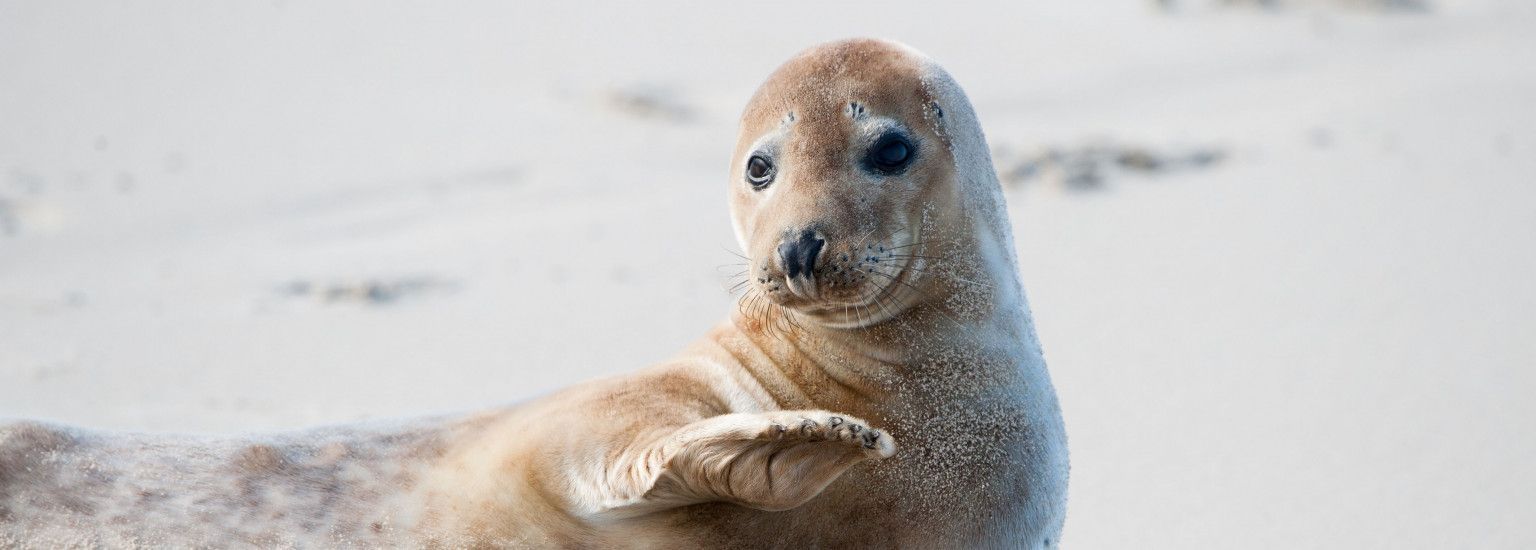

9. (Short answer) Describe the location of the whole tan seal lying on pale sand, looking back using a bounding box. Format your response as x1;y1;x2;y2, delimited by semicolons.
0;40;1068;548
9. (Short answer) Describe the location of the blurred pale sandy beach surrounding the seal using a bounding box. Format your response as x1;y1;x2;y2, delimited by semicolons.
0;0;1536;548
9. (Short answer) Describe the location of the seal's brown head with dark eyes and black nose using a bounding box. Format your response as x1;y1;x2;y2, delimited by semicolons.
730;40;1011;327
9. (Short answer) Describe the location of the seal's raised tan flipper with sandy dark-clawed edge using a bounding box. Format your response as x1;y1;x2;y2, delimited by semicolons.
601;410;895;518
